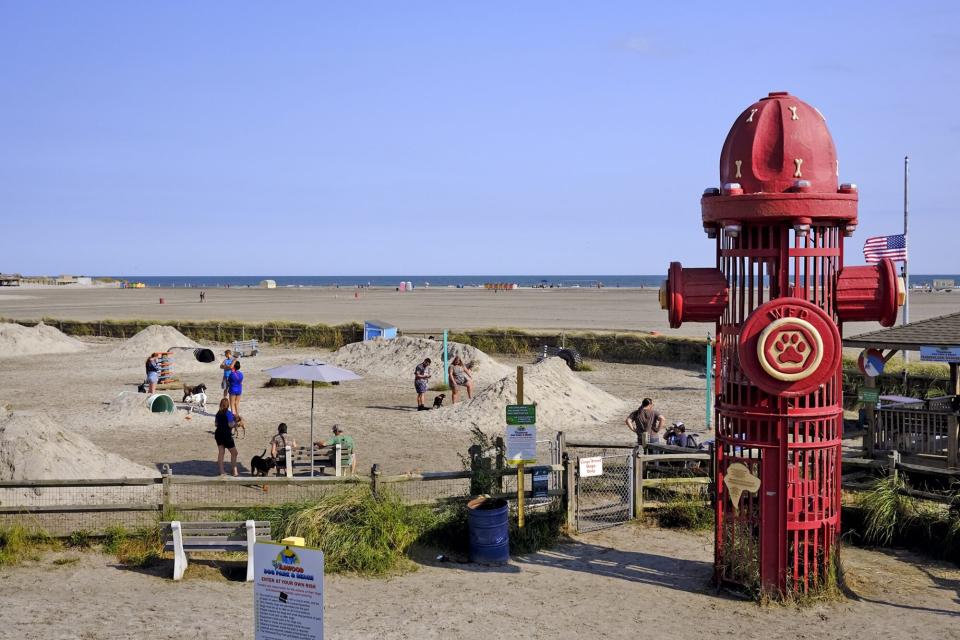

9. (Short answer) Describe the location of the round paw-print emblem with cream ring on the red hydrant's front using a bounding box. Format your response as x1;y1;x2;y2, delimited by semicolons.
757;318;823;381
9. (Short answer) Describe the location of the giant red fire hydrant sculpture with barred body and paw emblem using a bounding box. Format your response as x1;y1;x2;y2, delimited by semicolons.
661;92;903;594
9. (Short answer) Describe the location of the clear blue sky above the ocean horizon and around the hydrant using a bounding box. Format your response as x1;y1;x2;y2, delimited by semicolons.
0;0;960;275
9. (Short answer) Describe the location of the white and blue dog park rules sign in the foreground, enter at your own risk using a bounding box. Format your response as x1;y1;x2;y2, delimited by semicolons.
253;542;323;640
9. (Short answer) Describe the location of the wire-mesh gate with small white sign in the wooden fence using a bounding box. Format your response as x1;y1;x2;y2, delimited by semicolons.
574;452;634;533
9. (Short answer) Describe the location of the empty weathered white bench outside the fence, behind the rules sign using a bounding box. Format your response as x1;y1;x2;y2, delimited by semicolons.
160;520;270;582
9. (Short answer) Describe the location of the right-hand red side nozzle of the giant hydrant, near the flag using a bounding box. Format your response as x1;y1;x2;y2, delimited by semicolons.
837;258;904;327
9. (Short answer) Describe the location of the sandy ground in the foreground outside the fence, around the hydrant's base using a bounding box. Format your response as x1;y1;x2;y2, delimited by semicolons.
0;526;960;640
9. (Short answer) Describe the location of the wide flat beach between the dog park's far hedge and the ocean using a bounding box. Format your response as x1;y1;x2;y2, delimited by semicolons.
0;288;960;336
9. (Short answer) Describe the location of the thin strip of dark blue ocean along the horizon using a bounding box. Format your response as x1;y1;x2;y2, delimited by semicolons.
111;274;960;288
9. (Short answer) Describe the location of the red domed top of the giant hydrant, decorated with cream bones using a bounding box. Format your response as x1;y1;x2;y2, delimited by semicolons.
720;91;839;194
